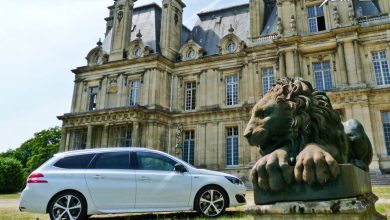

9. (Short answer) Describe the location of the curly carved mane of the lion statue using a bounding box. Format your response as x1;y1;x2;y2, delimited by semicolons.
269;78;349;163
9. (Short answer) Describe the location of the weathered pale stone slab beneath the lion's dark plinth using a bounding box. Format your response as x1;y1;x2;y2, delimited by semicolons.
245;193;386;220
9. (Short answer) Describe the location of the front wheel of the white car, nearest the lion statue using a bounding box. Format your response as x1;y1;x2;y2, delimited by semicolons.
194;186;228;218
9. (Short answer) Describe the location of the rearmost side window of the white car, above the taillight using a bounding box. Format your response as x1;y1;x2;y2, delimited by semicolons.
54;154;95;169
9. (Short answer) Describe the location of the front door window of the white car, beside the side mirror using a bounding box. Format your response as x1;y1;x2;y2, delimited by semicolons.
137;152;177;171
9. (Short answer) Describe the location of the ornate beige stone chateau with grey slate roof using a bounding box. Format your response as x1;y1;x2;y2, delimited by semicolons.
58;0;390;176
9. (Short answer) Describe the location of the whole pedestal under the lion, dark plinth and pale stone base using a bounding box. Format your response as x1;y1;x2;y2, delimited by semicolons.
246;164;386;220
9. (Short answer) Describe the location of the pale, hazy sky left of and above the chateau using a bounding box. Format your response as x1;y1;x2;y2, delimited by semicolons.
0;0;248;152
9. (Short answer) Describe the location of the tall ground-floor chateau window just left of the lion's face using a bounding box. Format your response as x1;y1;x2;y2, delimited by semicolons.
226;127;238;166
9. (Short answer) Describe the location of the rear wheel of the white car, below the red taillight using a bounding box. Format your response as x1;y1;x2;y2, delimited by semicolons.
48;191;87;220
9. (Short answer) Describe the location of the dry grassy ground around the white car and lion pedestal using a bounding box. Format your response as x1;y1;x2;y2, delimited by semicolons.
0;186;390;220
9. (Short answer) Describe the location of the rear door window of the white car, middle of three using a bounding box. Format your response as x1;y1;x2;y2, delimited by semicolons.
90;151;130;169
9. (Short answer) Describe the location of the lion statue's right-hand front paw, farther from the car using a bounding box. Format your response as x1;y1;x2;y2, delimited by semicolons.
294;144;340;185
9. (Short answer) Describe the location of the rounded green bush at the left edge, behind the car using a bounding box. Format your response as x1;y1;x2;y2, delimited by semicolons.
0;158;25;194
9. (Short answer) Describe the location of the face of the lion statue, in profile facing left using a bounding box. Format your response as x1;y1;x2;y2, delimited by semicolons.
244;93;292;155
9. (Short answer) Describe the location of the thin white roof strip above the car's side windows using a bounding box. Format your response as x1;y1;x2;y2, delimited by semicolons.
54;147;160;157
